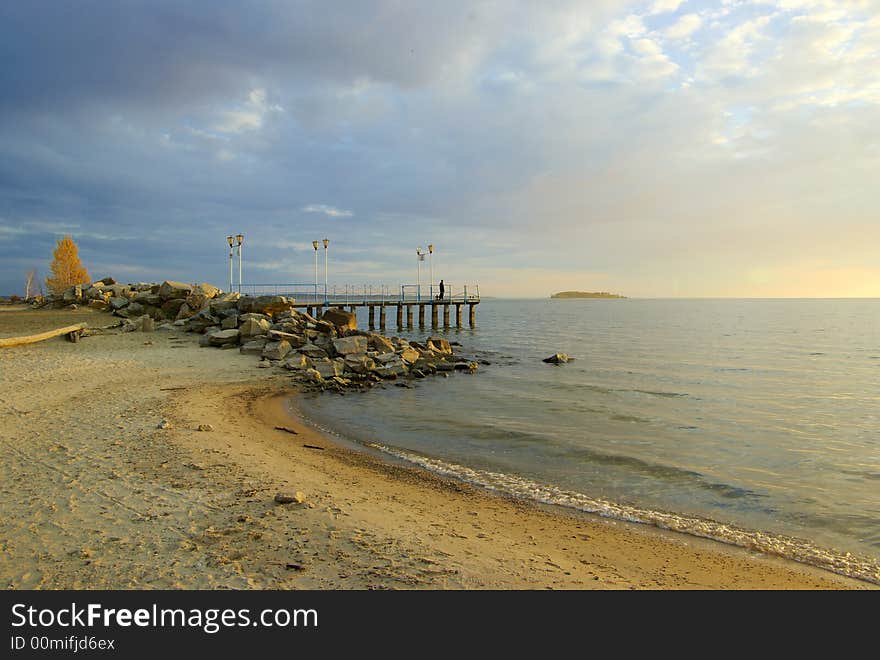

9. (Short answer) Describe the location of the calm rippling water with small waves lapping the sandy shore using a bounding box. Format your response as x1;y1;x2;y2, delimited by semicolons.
299;299;880;581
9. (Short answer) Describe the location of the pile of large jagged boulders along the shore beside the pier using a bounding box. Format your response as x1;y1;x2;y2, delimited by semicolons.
43;278;478;392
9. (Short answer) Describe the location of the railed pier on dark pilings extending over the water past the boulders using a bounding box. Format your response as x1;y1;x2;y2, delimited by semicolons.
238;283;480;330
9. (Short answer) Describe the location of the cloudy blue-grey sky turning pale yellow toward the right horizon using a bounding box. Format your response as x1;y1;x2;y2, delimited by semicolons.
0;0;880;297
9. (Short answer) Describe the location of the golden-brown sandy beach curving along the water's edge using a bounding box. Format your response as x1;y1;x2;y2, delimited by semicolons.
0;307;873;589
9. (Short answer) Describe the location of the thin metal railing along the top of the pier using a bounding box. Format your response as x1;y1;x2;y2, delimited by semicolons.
238;282;480;305
